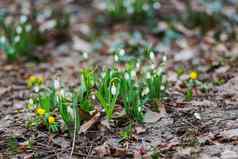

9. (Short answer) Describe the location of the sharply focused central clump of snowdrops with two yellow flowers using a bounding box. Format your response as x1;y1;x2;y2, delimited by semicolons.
28;59;167;132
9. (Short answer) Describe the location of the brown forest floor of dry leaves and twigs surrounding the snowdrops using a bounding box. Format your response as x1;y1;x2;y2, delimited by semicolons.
0;1;238;159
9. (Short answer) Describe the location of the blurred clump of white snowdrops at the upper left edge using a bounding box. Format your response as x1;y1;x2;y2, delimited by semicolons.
0;15;46;61
